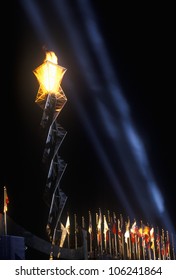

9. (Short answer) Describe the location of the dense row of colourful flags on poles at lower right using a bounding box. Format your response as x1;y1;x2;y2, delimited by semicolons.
57;209;175;260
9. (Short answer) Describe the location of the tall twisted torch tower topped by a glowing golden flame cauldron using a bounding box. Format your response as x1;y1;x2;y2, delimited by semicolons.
33;51;67;248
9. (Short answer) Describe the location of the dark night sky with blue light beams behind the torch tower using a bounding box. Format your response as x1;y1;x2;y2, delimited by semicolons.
0;0;176;245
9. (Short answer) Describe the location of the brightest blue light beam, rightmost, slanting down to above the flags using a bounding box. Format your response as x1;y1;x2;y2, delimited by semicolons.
67;0;175;234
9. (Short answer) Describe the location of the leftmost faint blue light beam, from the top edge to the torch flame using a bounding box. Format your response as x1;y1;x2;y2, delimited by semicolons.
20;0;56;49
